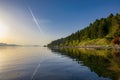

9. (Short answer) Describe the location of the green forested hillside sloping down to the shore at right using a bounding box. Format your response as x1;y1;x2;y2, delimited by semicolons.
48;14;120;46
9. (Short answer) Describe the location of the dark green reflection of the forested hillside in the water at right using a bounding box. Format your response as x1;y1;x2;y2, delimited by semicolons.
52;48;120;80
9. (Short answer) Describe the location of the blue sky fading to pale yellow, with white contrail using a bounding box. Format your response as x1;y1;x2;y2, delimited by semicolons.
0;0;120;45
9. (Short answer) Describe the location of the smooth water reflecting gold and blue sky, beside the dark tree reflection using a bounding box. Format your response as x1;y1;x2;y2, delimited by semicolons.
0;47;114;80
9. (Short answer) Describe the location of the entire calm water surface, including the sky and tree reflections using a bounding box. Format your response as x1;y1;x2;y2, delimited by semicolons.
0;47;120;80
